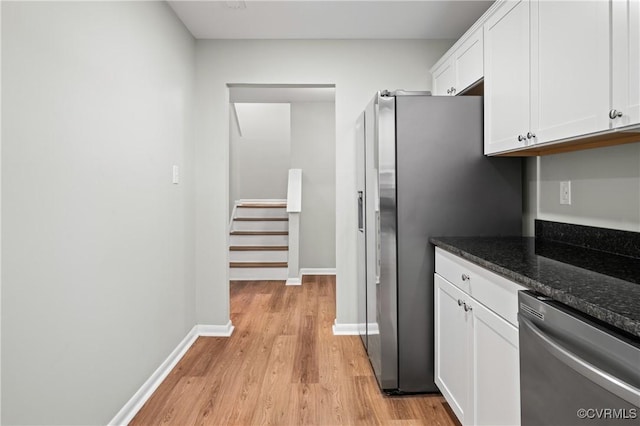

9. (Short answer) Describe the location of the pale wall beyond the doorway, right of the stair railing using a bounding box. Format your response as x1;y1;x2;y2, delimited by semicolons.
291;102;336;269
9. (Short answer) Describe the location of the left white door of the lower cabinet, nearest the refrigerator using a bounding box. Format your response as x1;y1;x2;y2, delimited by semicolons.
434;274;471;424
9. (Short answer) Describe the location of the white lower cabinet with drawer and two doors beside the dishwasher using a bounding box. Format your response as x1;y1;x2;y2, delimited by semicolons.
434;249;523;426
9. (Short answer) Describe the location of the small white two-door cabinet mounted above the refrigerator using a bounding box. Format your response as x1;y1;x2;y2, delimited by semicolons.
432;28;484;96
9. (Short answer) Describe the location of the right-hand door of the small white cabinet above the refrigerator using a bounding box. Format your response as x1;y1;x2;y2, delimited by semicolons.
454;28;484;95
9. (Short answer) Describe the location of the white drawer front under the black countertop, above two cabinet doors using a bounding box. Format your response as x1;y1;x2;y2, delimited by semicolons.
436;247;526;327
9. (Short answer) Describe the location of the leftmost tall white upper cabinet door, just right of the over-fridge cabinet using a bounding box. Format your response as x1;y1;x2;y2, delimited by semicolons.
484;0;530;154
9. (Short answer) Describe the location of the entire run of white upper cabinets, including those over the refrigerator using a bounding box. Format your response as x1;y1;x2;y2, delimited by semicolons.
431;0;640;156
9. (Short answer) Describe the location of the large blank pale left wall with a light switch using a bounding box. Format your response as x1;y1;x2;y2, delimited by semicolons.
2;2;195;425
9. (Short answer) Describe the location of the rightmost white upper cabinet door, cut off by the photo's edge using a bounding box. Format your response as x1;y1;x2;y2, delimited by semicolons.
610;0;640;128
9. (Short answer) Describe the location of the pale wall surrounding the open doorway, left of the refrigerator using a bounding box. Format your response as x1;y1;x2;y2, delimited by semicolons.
196;40;452;325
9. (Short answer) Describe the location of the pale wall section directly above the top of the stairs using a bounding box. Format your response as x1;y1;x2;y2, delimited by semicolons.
229;103;291;205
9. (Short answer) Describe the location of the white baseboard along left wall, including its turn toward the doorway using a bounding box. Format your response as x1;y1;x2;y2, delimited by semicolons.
108;321;234;426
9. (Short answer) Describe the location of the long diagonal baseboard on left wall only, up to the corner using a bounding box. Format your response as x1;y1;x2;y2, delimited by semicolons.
108;326;198;426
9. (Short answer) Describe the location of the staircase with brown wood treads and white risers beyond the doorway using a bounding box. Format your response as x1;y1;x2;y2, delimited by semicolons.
229;201;289;281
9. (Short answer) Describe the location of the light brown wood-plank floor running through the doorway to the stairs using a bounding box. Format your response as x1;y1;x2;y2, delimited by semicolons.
130;276;458;426
